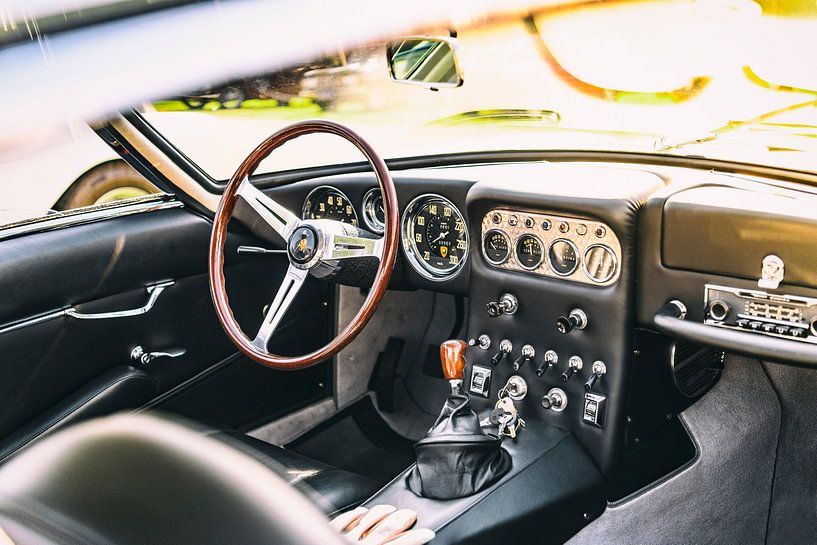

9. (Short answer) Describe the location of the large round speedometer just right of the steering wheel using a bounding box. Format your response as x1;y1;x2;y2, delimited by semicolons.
402;195;468;280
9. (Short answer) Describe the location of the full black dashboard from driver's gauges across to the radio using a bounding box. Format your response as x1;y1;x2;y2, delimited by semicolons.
258;163;817;472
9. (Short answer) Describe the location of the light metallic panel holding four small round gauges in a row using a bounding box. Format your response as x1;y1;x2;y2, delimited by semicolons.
481;209;621;286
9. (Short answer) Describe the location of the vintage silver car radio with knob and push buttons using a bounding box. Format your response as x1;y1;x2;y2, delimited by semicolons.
704;284;817;344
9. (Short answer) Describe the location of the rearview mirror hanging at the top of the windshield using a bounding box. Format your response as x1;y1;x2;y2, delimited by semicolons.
386;36;462;89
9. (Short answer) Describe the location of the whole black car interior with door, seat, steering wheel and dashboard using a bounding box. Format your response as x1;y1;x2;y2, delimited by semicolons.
0;1;817;545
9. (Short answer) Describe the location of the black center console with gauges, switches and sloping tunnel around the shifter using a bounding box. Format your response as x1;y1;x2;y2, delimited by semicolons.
367;165;661;544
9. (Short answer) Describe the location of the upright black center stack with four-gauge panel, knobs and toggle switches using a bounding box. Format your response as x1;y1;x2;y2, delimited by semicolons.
466;165;660;474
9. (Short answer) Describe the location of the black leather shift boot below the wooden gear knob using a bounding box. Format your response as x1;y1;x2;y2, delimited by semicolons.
407;388;511;500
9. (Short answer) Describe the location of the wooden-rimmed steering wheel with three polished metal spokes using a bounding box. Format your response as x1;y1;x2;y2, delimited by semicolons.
208;120;399;370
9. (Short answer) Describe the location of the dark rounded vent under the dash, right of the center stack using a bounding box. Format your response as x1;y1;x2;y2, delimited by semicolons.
670;341;725;397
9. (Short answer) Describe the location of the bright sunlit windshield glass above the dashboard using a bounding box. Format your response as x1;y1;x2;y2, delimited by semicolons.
142;0;817;180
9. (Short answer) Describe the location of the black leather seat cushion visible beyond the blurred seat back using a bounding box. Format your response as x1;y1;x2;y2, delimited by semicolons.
207;430;380;515
